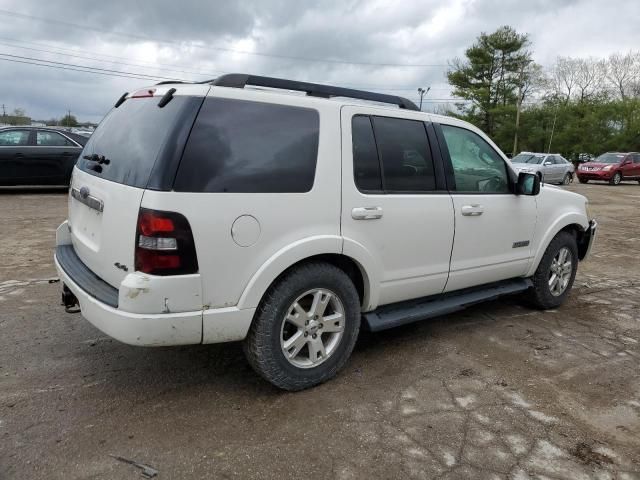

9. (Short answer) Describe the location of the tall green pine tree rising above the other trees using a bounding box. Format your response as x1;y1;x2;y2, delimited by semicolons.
447;26;532;135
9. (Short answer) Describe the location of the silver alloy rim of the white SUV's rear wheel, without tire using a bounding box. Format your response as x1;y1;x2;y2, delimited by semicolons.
280;288;345;368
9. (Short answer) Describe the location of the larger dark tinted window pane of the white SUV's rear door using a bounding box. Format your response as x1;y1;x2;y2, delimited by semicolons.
372;117;436;192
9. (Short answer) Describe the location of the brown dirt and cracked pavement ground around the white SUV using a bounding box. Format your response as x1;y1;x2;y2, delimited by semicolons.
0;183;640;480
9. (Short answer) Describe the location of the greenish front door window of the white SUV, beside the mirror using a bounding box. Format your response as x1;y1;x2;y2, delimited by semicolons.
442;125;509;193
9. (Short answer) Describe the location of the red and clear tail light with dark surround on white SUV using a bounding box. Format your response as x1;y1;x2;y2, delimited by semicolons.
135;208;198;275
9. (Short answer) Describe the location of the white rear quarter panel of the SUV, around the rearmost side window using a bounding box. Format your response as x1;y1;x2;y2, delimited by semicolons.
142;87;342;309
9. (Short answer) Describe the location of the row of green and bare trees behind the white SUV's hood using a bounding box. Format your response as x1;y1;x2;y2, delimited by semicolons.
443;26;640;160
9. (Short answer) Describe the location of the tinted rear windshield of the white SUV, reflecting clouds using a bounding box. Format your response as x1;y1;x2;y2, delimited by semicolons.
78;96;191;188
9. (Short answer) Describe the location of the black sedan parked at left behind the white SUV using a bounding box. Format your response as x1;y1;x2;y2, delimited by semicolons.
0;127;87;186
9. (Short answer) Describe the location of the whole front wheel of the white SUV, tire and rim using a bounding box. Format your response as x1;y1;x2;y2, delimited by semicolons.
528;232;578;310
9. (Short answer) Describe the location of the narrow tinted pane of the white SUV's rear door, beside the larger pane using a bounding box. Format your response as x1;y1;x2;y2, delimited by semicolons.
351;115;382;191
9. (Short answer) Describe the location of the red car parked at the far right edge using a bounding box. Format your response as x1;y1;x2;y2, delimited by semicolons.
577;152;640;185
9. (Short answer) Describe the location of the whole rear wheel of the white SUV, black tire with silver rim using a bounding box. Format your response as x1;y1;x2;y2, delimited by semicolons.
244;262;360;391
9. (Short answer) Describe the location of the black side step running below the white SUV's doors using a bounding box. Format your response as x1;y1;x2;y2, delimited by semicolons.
362;278;533;332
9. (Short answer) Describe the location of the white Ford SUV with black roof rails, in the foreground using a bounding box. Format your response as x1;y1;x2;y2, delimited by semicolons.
55;74;596;390
